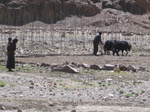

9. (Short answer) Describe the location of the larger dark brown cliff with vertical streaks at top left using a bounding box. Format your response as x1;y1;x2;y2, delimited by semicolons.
0;0;100;25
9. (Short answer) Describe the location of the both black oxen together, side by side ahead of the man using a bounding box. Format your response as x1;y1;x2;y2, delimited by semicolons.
103;40;131;56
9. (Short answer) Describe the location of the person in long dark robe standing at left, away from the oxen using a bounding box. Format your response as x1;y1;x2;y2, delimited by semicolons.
6;38;18;71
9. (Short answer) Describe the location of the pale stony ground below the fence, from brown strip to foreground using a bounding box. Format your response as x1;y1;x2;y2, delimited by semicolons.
0;55;150;112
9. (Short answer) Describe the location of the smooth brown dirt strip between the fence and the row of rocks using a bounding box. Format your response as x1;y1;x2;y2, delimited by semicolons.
16;54;150;69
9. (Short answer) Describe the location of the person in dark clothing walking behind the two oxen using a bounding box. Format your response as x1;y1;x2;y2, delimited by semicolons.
93;32;102;55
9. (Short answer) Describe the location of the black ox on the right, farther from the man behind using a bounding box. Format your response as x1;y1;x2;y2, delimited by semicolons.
112;41;131;56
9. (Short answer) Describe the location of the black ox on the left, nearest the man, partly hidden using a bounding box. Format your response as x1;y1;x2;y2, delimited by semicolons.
103;40;117;54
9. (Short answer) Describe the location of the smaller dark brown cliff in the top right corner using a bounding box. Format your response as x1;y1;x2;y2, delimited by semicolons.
102;0;150;15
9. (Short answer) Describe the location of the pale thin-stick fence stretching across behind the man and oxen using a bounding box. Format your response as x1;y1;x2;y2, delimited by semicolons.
0;24;150;57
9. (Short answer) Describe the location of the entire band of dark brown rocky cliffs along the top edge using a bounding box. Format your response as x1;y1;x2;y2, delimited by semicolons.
0;0;150;25
